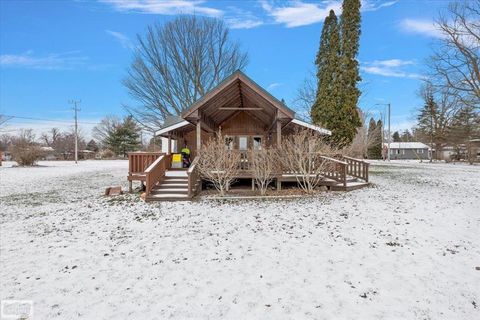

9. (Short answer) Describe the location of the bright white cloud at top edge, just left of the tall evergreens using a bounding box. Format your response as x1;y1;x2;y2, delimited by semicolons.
261;1;342;28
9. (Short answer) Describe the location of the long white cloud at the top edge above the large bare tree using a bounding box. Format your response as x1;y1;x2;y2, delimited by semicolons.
99;0;223;17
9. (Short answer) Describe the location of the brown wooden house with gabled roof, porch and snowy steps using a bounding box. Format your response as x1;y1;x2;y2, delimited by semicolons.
128;71;368;200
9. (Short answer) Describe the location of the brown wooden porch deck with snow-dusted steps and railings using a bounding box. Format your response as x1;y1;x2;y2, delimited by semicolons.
128;152;369;201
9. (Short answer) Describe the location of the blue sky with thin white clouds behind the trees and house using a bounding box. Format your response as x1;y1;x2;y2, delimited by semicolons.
0;0;448;137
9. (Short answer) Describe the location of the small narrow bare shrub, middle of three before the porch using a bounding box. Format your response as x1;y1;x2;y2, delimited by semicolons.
250;146;280;196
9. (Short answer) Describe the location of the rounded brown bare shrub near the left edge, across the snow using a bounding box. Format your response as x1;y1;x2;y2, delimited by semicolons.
10;129;42;166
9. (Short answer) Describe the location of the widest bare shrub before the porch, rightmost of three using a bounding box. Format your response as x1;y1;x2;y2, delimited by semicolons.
279;129;335;193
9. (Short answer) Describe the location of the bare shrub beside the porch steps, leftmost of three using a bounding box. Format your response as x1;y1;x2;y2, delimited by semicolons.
197;132;240;197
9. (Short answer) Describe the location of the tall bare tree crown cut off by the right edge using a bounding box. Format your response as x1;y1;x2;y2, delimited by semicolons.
430;0;480;108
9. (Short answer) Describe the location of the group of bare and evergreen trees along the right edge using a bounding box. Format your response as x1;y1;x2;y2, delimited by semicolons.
414;0;480;162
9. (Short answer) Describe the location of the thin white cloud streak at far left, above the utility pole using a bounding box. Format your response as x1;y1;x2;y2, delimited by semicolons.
0;51;88;70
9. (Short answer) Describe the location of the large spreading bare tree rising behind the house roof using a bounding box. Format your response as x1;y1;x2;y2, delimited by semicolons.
123;16;247;128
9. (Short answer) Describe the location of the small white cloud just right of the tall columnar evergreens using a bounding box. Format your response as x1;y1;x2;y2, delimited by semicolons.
361;59;422;79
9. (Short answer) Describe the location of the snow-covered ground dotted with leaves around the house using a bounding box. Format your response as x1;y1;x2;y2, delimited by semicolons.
0;161;480;320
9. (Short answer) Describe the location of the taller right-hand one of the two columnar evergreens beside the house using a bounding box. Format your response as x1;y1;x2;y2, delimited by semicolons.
333;0;361;145
